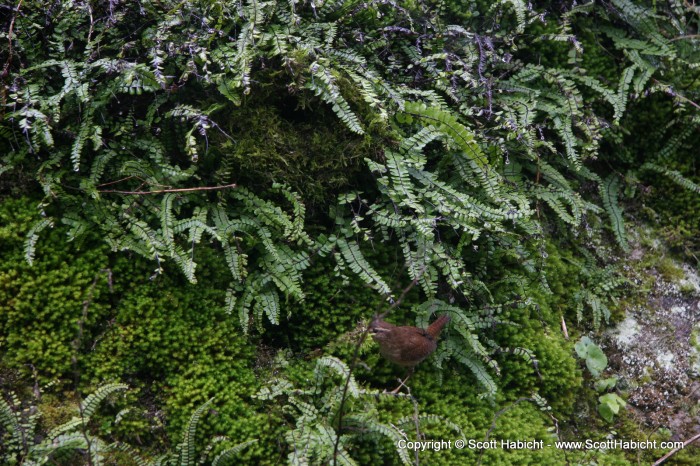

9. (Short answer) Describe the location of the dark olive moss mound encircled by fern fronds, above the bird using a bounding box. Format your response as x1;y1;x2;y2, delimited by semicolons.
214;77;378;214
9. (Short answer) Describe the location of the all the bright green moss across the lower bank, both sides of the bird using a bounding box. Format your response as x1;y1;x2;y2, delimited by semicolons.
0;187;696;465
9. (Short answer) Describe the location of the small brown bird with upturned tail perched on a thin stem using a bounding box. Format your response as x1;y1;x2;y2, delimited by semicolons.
369;315;450;393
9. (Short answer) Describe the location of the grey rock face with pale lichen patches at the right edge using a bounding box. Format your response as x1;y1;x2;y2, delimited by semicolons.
605;266;700;440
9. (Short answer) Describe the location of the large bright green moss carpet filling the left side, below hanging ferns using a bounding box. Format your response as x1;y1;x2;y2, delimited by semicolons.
0;199;275;461
